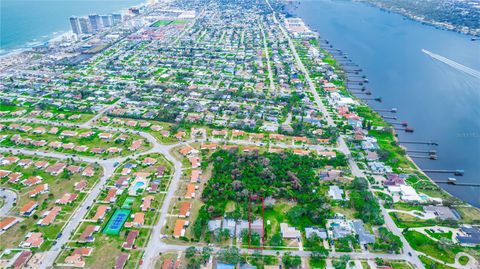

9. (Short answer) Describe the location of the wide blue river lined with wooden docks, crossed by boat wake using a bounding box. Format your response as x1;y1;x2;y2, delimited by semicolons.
290;0;480;206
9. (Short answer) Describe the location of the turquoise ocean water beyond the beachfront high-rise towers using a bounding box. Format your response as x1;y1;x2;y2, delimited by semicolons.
0;0;144;53
